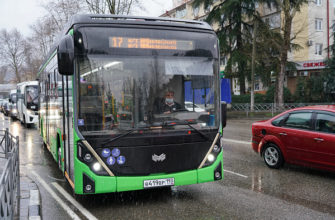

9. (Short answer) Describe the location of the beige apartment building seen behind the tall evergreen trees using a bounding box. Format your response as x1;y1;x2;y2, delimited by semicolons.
161;0;335;95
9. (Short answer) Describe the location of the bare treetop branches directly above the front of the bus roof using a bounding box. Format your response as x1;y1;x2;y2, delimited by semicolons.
85;0;144;15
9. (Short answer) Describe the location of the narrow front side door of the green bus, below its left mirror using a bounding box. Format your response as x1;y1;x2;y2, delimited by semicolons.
62;76;72;177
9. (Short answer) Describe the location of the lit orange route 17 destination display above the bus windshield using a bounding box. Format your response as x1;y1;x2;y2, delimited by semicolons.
109;37;194;50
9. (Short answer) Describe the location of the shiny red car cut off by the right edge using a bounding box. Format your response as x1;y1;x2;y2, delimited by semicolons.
252;105;335;171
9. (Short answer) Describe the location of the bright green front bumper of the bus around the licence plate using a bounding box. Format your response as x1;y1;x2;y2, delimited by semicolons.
75;152;223;194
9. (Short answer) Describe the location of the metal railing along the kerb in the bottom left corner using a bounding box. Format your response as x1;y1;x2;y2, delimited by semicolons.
0;129;20;220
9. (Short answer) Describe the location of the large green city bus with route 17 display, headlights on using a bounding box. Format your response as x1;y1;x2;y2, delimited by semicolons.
38;15;225;194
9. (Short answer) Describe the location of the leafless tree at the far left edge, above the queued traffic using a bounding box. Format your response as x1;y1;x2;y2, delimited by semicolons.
0;29;26;82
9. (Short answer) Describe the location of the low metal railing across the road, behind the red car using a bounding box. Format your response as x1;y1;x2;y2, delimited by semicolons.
228;103;335;116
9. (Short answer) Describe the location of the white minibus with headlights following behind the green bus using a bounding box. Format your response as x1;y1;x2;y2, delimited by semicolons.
17;81;39;127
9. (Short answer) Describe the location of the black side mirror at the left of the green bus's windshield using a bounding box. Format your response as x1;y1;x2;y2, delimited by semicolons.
57;35;74;76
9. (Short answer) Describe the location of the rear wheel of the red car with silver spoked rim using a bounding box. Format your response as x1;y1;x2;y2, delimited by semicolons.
263;143;284;169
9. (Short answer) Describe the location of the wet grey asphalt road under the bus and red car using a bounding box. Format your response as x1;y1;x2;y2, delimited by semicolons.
0;114;335;219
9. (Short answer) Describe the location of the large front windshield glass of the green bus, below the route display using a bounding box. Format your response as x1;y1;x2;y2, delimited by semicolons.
78;56;219;132
